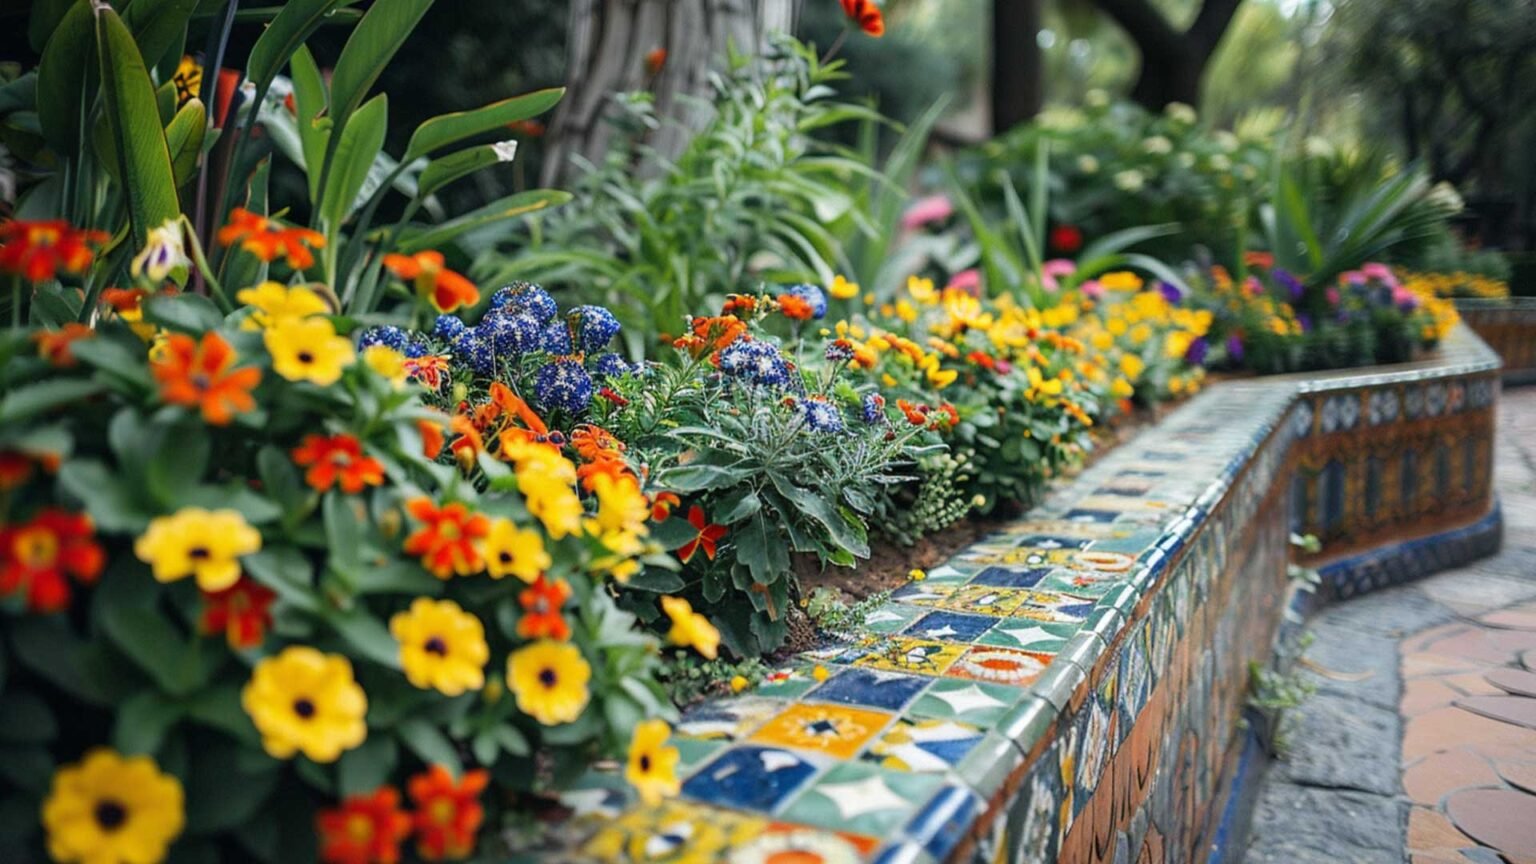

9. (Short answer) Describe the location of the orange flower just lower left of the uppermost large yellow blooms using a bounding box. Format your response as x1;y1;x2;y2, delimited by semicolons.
149;331;261;426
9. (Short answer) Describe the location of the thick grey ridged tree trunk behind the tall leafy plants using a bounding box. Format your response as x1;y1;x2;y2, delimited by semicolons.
544;0;799;186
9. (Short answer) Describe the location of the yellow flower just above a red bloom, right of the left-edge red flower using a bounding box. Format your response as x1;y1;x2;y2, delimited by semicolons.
134;507;261;590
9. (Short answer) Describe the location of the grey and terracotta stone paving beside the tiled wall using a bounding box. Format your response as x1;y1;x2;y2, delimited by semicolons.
1246;387;1536;864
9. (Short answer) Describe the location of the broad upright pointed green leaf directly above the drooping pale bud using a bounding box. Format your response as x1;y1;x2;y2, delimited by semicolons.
94;5;181;248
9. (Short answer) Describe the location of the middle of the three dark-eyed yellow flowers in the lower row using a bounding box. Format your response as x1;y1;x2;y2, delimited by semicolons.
389;596;490;696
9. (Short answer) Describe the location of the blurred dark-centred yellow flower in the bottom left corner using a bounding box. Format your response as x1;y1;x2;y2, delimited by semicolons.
43;747;186;864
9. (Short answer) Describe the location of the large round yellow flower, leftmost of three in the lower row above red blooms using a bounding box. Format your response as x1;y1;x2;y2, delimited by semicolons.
240;646;369;763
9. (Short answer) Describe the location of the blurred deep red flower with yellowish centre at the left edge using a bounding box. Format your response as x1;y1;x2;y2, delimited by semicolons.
0;507;106;612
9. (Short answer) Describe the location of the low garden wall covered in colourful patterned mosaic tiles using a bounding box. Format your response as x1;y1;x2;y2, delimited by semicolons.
524;327;1498;862
